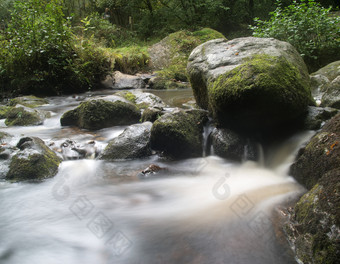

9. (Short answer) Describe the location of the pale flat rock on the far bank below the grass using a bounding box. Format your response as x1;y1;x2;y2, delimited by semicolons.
102;71;146;89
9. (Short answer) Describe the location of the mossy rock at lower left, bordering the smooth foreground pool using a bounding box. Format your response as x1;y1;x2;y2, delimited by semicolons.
6;137;61;181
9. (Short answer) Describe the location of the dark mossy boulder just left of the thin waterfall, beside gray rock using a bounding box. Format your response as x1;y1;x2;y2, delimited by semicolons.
151;110;208;159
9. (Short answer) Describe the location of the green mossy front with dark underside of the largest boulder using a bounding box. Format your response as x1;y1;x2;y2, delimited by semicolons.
208;55;312;131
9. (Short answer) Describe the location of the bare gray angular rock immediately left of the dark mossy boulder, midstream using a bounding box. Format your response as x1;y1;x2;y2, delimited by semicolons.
100;122;152;160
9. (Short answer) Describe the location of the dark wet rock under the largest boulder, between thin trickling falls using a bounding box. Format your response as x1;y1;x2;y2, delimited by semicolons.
210;128;258;161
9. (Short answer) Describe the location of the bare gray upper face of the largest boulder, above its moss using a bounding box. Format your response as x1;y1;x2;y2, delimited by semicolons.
187;37;310;109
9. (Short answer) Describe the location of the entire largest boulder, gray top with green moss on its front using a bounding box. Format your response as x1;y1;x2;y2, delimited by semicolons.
187;37;313;130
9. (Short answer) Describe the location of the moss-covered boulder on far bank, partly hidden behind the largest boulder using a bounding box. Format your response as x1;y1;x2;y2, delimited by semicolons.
149;28;224;84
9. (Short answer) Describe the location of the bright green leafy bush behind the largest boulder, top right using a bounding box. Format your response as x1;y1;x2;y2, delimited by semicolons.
251;0;340;70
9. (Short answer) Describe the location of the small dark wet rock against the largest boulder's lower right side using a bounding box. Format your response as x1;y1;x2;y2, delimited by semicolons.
303;106;338;130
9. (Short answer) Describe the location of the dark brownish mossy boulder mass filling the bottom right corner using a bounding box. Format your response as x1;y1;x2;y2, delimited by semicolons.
285;114;340;264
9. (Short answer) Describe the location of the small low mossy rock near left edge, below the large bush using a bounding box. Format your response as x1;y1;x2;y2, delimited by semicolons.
5;104;49;126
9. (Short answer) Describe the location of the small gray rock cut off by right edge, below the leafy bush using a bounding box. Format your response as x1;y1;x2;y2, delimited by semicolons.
321;76;340;109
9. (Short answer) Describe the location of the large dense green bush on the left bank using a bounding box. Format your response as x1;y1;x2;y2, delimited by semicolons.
0;0;109;95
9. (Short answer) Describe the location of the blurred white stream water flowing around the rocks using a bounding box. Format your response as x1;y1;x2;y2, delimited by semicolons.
0;88;310;264
